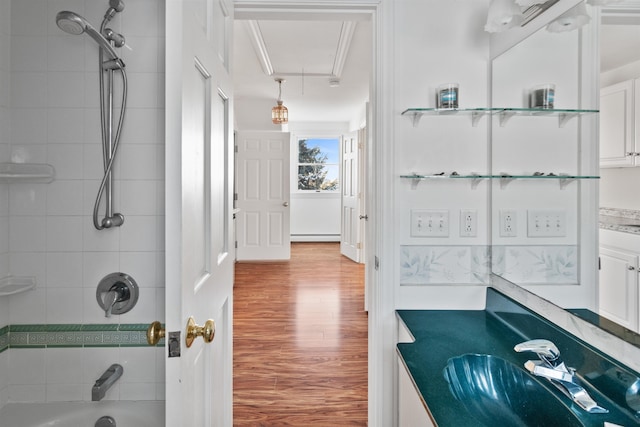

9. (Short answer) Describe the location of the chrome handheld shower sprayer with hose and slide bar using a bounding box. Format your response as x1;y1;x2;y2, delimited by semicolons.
56;0;127;230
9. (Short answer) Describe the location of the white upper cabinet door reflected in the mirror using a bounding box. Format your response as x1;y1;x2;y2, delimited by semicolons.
600;80;636;167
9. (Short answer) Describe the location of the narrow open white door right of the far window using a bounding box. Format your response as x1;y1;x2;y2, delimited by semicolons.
340;132;361;262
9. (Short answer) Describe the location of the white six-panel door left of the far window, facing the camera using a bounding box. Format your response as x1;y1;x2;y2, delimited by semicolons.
236;131;291;261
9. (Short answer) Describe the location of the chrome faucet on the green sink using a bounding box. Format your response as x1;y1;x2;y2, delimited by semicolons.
513;340;609;414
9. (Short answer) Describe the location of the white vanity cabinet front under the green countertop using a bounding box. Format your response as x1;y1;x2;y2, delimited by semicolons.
396;321;436;427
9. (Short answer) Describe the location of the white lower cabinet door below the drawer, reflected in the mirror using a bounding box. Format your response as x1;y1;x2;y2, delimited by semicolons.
598;246;639;332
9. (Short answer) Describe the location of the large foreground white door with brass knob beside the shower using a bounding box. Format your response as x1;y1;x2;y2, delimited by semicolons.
165;0;234;427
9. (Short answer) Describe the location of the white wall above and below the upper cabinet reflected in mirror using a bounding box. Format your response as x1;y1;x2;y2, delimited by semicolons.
600;61;640;210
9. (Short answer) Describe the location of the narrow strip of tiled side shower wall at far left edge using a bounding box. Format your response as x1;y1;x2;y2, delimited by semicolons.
0;0;11;407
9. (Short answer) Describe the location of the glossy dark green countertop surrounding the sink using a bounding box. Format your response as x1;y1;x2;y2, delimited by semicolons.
397;290;640;427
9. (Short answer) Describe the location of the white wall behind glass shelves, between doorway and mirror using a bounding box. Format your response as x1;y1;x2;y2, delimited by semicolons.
390;0;489;309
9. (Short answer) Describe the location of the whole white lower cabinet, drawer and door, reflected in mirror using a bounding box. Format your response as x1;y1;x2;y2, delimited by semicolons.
598;230;640;332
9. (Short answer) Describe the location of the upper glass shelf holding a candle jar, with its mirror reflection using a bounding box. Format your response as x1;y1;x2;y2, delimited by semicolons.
402;108;599;127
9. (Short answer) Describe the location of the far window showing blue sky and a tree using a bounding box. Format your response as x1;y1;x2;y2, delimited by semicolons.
298;138;340;191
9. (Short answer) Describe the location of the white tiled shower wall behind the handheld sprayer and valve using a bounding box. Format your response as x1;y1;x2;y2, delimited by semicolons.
0;0;164;403
